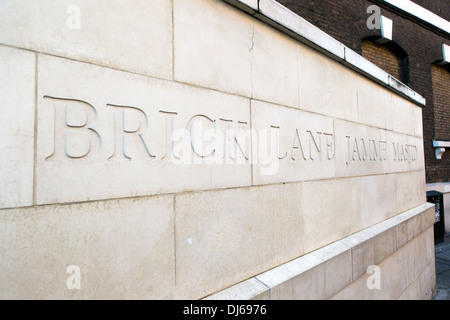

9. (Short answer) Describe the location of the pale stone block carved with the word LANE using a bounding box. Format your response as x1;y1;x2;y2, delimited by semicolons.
251;100;336;184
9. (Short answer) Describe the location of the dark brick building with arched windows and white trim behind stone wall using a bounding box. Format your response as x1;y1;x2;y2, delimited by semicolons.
277;0;450;231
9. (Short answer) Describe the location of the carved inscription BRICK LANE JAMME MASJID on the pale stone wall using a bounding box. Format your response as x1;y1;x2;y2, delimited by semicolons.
44;96;418;170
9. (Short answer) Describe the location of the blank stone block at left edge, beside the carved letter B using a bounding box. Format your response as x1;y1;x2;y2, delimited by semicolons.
0;46;36;208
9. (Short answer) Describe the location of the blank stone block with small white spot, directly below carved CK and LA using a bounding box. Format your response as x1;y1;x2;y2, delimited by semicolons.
176;184;303;299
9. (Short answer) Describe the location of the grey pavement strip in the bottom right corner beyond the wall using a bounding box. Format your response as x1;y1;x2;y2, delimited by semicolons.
434;233;450;300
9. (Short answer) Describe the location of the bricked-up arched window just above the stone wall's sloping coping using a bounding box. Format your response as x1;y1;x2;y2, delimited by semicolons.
361;37;410;85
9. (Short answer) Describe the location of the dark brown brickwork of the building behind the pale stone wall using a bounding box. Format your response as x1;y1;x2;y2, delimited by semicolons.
277;0;450;183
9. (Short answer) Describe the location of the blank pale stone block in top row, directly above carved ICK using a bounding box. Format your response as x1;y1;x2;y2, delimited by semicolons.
174;0;254;97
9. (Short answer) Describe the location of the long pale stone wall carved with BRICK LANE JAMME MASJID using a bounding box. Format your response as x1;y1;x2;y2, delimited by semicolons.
0;0;434;299
